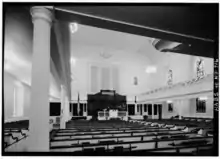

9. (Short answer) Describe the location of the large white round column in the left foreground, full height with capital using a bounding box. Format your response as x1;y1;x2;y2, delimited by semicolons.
28;7;52;152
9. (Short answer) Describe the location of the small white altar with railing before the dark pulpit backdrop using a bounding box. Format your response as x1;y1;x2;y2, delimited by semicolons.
98;109;128;121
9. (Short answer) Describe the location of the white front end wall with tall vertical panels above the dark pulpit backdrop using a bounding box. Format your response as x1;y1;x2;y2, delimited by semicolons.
71;59;165;101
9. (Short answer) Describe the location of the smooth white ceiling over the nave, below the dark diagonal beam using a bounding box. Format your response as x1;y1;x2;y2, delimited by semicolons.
71;24;165;66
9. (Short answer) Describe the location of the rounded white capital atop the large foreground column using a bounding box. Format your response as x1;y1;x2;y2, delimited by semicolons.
30;6;53;24
